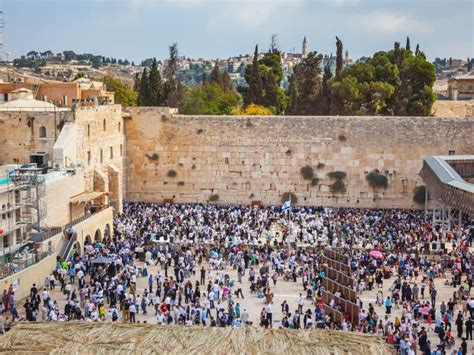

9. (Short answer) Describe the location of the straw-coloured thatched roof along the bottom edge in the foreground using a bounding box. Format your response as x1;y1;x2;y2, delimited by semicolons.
0;322;393;355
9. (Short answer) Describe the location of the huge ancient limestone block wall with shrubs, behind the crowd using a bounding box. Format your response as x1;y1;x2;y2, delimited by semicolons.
125;108;474;208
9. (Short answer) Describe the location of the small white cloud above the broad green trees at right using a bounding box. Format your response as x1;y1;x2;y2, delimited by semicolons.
354;11;433;34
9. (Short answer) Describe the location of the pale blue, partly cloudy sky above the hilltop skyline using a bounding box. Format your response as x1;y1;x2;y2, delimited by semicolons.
0;0;474;62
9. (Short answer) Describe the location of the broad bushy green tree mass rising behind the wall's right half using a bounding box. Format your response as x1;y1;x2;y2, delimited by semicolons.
329;42;435;116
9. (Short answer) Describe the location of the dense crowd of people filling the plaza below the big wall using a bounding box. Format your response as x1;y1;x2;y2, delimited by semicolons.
0;203;474;355
